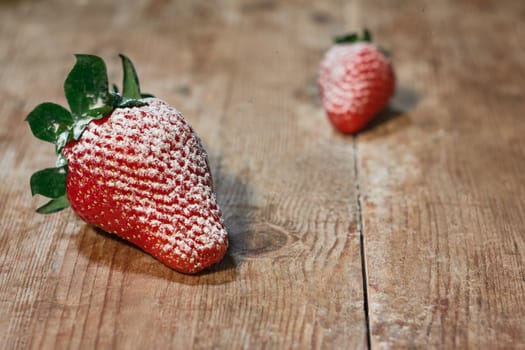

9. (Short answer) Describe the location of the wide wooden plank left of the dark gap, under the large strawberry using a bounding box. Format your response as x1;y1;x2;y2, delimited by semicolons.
0;1;366;349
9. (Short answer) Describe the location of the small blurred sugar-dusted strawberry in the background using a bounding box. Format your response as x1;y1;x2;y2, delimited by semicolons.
318;30;395;133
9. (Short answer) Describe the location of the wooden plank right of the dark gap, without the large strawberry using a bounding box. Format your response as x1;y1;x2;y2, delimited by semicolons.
357;1;525;349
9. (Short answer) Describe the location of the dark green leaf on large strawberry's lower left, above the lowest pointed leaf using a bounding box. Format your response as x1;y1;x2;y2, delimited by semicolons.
30;166;66;198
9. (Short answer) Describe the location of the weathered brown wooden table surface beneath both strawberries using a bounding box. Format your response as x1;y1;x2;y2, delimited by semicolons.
0;0;525;349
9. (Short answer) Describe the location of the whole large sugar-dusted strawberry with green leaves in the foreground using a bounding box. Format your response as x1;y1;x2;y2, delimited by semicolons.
27;55;228;273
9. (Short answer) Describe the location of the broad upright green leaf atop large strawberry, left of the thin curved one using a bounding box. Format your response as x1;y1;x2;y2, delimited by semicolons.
64;55;108;118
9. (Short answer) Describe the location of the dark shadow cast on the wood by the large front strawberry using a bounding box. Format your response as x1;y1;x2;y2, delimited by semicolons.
69;161;246;285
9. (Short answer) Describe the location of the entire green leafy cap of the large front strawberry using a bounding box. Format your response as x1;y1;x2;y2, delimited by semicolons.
26;54;152;214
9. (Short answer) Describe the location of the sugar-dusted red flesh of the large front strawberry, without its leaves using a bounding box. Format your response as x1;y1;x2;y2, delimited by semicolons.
63;98;228;272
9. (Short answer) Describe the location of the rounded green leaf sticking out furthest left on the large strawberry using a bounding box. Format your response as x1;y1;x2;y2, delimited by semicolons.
26;102;73;144
